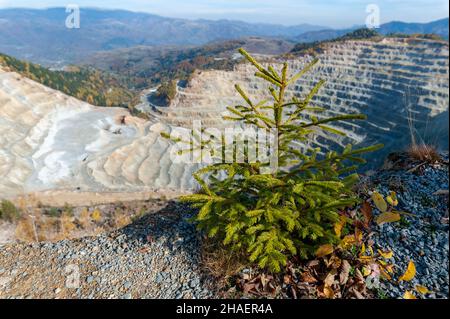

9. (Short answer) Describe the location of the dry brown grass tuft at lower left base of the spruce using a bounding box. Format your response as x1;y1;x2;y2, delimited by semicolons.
202;238;248;289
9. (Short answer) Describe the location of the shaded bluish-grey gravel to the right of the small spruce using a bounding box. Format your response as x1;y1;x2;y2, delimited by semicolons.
370;155;449;298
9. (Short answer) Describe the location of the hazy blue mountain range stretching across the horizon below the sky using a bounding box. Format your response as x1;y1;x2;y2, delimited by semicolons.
0;8;448;65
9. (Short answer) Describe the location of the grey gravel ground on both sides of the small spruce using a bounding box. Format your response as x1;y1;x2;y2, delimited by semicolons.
0;156;449;298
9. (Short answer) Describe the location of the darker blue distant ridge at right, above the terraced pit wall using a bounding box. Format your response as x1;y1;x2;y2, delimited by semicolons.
295;18;449;42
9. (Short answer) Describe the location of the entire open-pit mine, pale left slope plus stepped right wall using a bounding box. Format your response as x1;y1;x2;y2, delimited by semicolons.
0;39;449;203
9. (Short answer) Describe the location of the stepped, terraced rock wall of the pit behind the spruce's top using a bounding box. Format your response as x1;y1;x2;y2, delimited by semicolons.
153;39;449;165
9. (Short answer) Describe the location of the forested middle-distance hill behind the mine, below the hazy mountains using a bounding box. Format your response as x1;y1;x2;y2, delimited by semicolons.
86;37;286;89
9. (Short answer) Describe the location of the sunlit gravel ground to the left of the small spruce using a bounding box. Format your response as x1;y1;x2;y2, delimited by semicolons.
0;204;214;299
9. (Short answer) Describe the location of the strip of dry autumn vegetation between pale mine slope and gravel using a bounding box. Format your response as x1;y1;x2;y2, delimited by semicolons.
0;198;167;242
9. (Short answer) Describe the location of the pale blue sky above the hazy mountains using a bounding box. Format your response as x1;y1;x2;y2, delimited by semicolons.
0;0;449;27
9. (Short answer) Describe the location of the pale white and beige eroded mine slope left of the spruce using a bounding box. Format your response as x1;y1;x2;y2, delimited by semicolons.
0;70;200;200
